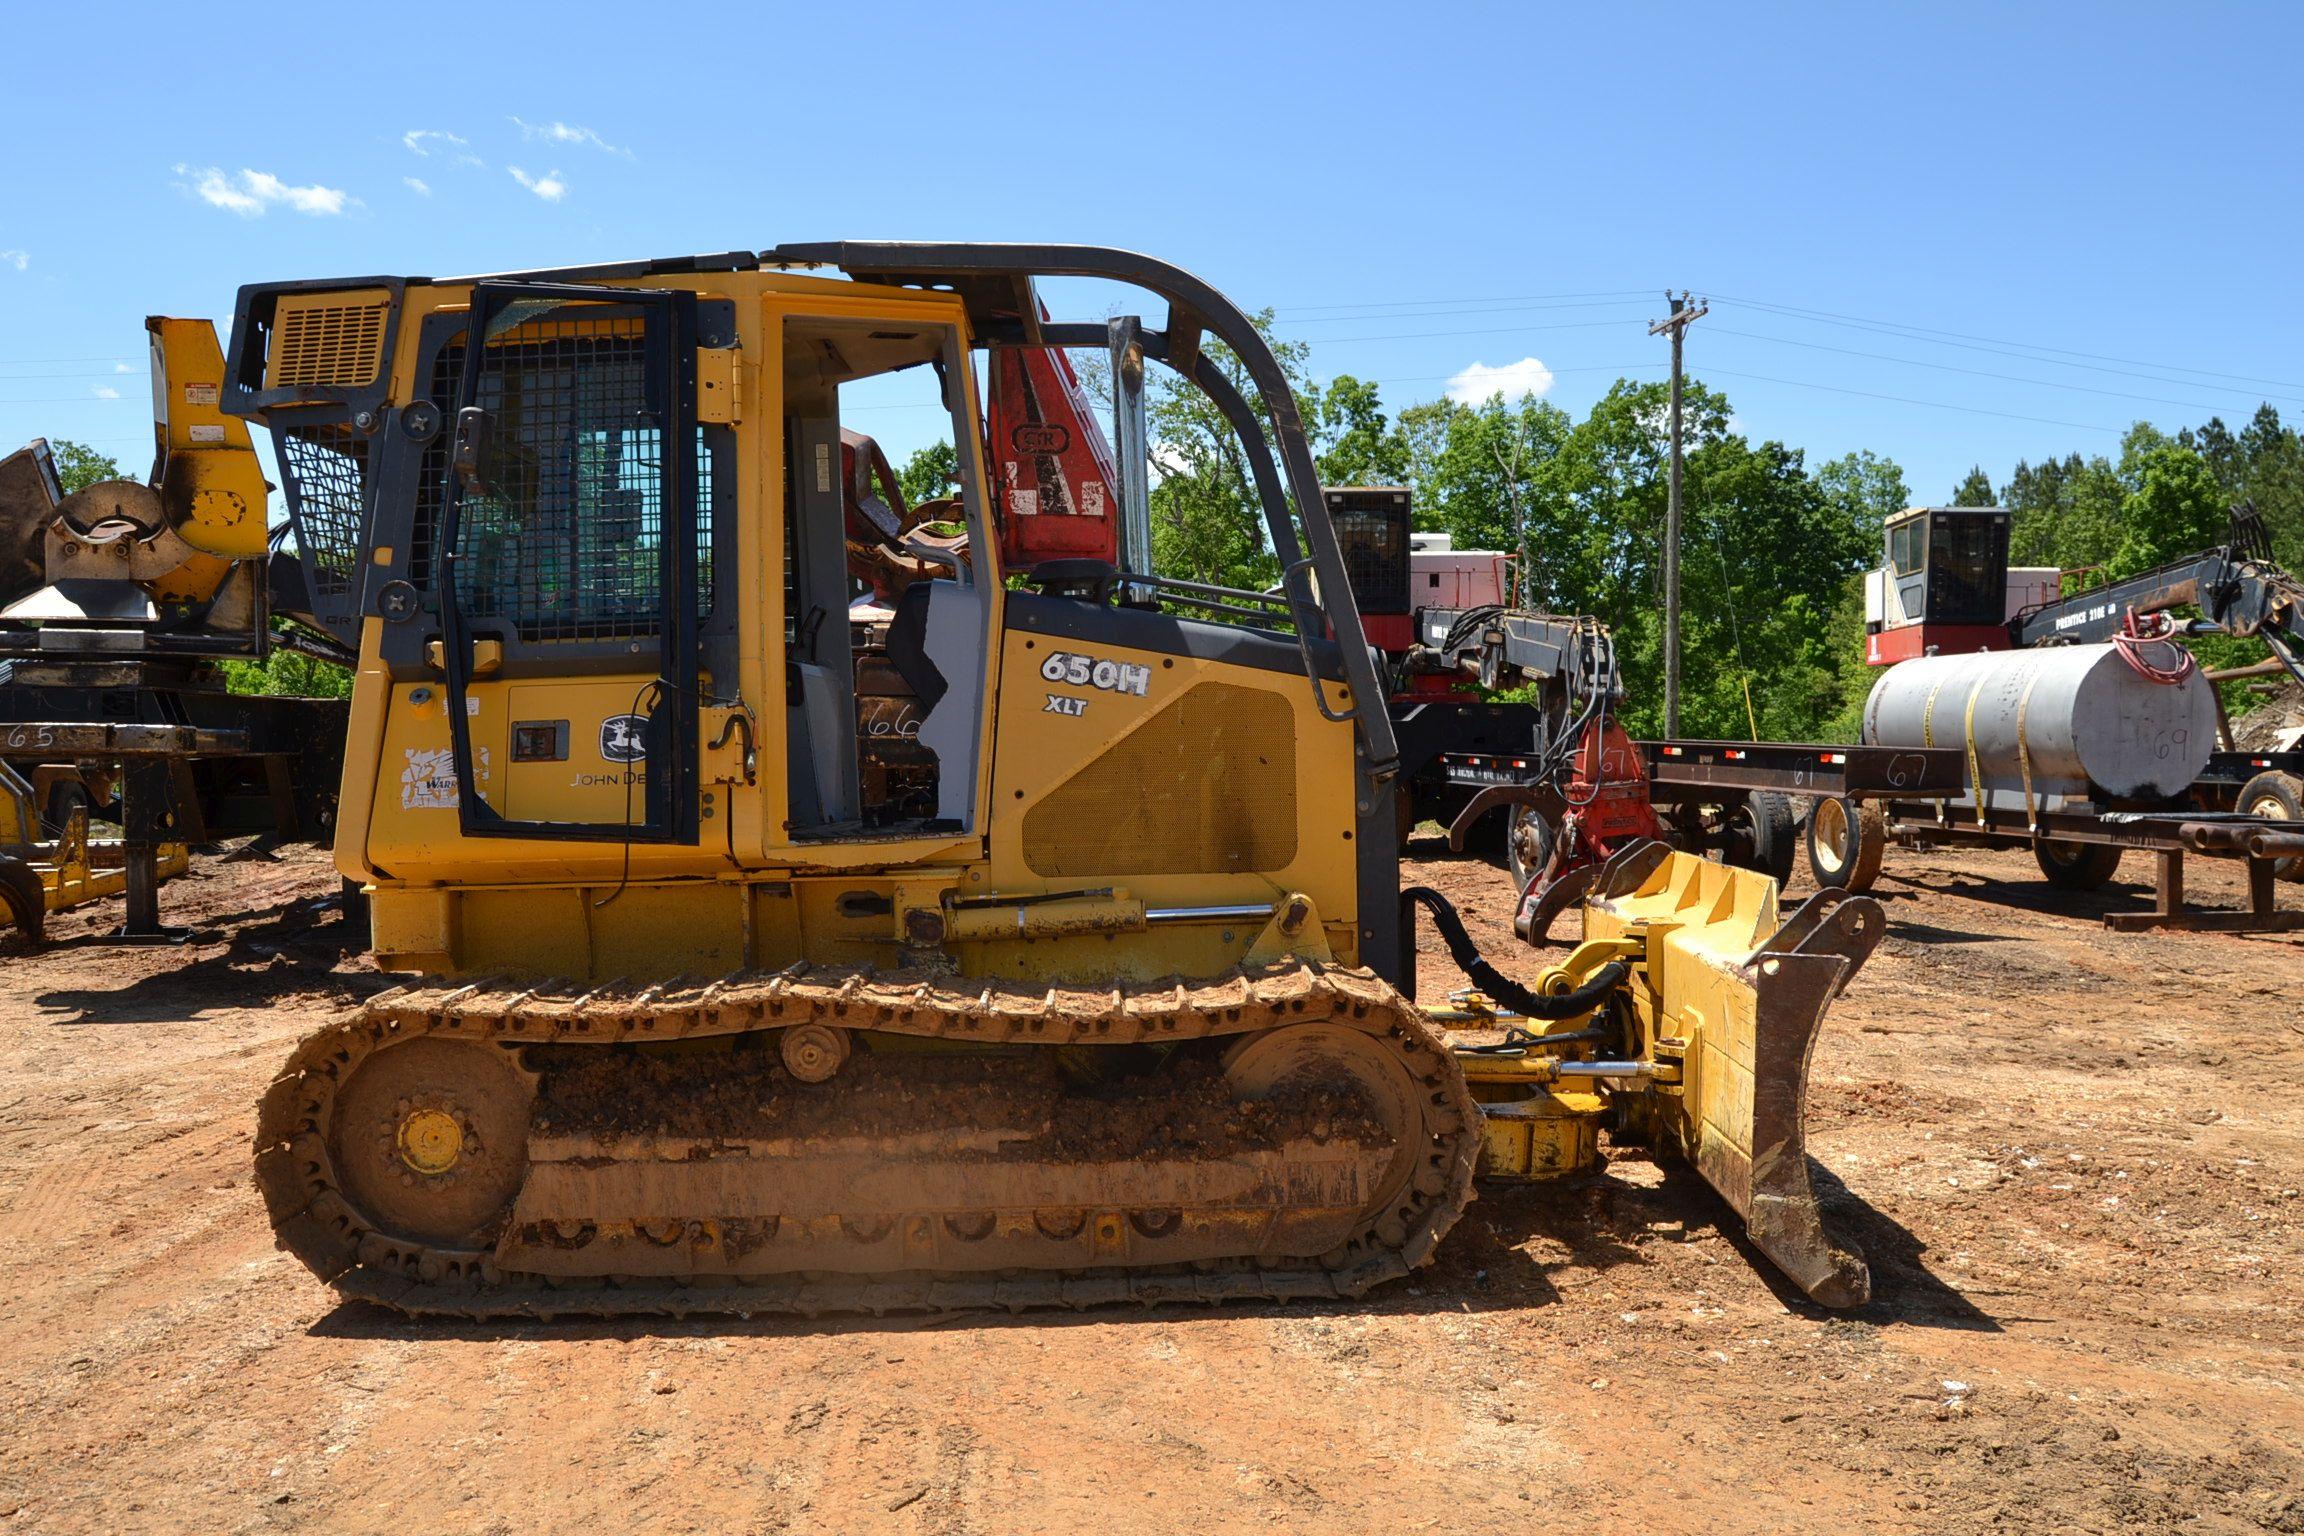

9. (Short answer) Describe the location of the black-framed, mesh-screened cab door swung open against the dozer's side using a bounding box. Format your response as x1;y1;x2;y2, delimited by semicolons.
438;283;703;843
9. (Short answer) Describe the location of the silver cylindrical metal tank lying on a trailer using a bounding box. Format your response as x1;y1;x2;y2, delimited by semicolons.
1864;640;2216;799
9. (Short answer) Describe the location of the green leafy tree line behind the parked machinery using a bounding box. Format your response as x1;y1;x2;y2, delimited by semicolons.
908;311;2304;742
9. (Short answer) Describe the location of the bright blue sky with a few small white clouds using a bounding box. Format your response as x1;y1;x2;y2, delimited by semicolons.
0;0;2304;500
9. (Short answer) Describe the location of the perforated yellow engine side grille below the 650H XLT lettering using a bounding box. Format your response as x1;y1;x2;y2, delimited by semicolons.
1023;682;1297;880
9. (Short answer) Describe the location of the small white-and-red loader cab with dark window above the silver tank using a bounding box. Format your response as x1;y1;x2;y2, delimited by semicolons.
1864;507;2060;666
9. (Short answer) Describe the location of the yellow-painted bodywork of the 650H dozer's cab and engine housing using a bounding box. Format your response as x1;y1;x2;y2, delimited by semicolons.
270;272;1359;981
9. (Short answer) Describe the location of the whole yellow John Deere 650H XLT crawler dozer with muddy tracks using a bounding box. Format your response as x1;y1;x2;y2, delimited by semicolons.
228;244;1880;1315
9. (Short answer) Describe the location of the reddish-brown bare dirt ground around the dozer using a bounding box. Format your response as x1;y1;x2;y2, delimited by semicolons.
0;847;2304;1536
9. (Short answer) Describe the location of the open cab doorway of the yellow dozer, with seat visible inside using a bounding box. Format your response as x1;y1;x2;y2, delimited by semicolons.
760;292;1002;866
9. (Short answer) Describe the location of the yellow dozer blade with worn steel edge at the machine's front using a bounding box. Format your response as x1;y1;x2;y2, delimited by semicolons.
1583;843;1887;1308
